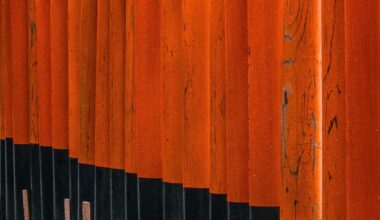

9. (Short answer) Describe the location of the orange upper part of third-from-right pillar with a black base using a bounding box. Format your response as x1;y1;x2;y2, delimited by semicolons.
210;0;227;194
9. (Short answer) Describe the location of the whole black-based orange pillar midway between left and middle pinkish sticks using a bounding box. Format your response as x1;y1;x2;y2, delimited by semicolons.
35;0;54;219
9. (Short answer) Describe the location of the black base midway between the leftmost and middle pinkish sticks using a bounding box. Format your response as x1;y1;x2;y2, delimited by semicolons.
40;147;54;219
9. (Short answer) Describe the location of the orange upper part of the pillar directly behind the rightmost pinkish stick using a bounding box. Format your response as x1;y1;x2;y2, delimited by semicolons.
78;0;97;165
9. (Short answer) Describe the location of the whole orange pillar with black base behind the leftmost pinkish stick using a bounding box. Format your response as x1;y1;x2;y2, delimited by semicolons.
10;1;30;219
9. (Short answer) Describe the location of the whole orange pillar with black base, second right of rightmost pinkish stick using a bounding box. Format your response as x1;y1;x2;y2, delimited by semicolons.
108;0;126;219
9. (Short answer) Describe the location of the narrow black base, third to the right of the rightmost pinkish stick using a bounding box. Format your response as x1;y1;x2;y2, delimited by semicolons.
126;173;139;219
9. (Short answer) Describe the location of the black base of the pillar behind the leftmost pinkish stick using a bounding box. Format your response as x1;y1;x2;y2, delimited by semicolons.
14;144;31;219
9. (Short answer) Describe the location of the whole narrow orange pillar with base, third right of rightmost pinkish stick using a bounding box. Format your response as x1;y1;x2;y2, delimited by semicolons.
124;0;138;219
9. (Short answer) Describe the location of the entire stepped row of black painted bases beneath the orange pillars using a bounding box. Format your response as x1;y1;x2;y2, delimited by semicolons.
0;139;280;220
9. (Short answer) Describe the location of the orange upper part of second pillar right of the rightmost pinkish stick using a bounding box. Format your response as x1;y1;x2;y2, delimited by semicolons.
109;0;126;170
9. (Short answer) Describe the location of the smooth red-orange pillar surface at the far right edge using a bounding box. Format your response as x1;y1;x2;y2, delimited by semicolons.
344;0;380;219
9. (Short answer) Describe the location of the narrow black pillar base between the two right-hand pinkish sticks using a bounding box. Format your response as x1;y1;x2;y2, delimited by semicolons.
70;158;79;220
